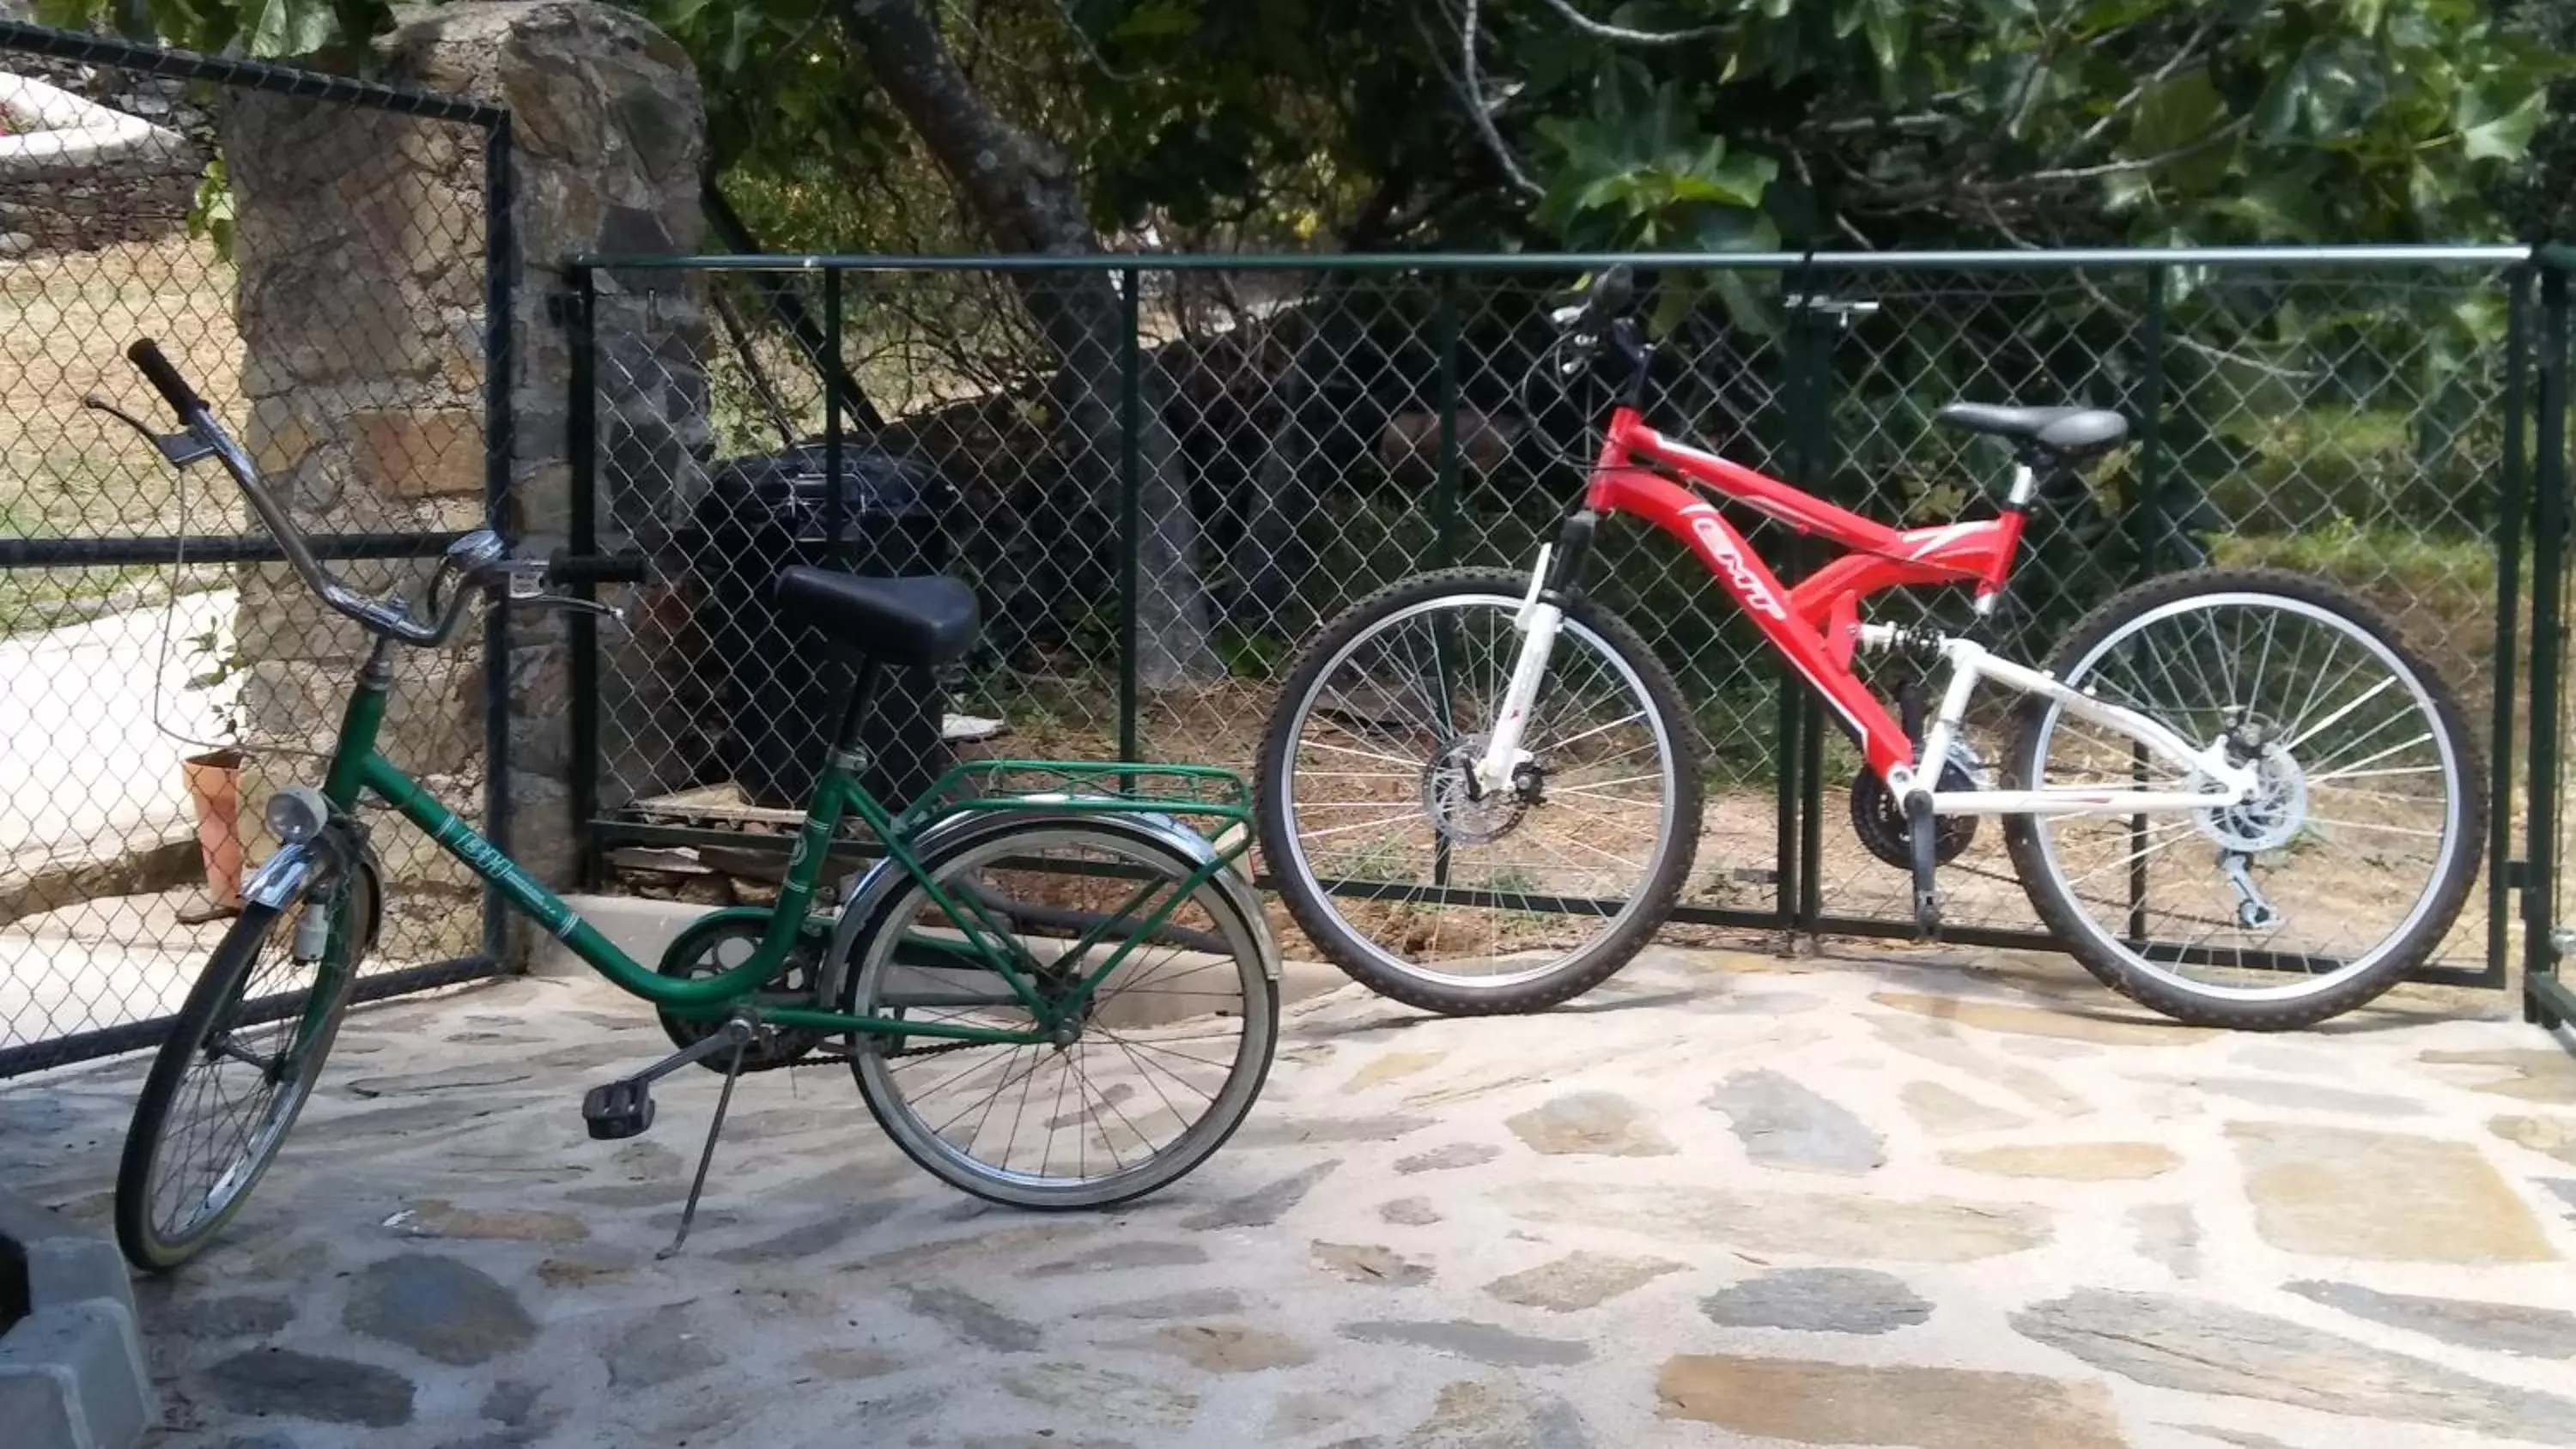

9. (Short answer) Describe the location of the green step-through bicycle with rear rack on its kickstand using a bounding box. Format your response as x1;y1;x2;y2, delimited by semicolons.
88;343;1278;1271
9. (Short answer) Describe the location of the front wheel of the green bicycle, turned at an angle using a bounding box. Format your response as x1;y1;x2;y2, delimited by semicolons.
116;872;376;1271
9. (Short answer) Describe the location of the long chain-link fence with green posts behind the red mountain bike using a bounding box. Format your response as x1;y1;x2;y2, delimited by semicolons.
559;247;2532;983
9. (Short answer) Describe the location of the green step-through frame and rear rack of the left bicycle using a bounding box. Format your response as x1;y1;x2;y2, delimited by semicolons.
307;644;1249;1045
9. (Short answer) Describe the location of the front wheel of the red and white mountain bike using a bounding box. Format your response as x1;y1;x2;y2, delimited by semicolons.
1257;569;1700;1016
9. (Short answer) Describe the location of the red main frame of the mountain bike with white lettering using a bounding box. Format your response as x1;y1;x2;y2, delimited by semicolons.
1584;404;2022;777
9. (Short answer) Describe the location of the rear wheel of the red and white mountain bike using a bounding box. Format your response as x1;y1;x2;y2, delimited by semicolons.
2004;569;2486;1029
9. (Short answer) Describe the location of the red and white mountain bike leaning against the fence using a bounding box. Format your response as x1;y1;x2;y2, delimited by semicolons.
1257;268;2486;1029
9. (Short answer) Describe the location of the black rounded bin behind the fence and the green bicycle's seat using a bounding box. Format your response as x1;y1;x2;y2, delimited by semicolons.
698;443;956;808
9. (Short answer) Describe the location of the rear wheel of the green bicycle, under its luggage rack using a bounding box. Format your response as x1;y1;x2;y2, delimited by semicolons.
842;815;1278;1207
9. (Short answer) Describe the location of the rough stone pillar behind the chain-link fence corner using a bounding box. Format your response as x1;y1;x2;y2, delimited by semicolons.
224;0;706;967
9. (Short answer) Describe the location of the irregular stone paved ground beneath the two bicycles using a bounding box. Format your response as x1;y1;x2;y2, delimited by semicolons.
0;952;2576;1449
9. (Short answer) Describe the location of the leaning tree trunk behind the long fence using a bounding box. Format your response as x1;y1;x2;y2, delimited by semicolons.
840;0;1224;690
